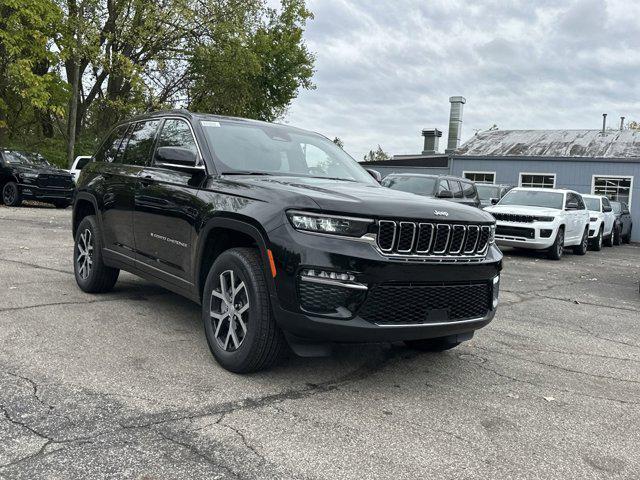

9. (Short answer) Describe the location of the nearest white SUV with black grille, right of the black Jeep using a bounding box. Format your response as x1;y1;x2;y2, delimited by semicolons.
485;187;589;260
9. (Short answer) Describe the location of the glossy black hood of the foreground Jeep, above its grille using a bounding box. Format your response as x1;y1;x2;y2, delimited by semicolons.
220;175;494;223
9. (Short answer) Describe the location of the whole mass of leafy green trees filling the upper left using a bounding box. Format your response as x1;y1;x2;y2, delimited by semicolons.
0;0;314;165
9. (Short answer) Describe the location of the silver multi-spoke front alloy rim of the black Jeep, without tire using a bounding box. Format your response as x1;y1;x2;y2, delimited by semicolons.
211;270;249;352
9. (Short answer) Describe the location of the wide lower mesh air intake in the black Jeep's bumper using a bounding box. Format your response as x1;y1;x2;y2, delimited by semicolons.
359;282;492;325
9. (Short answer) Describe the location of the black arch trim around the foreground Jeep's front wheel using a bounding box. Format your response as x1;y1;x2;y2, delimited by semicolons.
193;216;275;299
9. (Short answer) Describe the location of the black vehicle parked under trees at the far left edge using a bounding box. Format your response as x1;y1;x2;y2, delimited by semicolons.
0;150;75;208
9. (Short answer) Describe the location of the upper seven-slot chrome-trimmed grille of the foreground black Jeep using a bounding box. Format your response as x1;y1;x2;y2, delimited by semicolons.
377;220;491;257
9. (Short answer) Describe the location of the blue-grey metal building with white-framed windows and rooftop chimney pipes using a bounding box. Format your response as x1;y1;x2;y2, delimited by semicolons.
367;97;640;241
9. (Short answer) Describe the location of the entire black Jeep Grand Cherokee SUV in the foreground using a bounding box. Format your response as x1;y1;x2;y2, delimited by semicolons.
73;110;502;372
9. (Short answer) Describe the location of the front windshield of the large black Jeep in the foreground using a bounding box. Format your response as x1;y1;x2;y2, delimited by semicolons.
200;120;377;185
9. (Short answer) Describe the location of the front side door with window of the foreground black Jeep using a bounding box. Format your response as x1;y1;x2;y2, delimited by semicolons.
134;118;205;285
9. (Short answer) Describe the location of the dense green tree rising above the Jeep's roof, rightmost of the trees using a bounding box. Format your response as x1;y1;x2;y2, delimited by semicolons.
188;0;314;121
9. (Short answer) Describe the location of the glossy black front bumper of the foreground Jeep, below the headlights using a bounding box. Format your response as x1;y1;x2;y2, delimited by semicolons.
269;225;502;342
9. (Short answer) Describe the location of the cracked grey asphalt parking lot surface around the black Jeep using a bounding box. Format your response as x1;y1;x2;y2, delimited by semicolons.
0;207;640;479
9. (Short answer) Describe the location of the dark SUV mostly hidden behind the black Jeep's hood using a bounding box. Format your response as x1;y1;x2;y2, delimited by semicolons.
382;173;480;207
